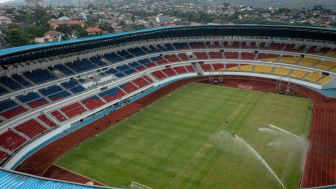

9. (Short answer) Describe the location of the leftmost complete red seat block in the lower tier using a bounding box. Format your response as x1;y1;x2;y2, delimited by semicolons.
0;130;27;151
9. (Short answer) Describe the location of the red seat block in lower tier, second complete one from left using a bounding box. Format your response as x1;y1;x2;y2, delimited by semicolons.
15;119;47;138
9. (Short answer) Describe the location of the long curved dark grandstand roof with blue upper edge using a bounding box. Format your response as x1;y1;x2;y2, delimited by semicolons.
0;25;336;65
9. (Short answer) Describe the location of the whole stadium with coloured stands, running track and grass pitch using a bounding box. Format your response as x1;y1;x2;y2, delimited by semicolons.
0;25;336;188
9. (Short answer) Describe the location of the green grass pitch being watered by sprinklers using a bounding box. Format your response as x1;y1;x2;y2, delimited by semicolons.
56;83;312;189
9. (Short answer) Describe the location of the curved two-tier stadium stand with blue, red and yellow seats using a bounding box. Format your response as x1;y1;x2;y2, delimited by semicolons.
0;26;336;189
